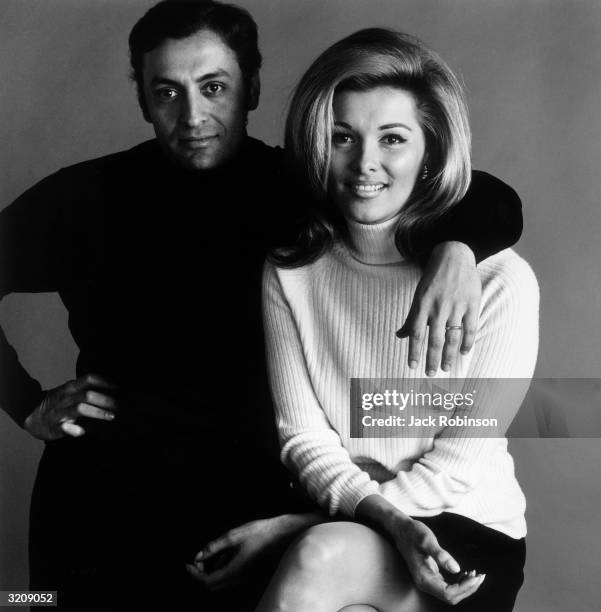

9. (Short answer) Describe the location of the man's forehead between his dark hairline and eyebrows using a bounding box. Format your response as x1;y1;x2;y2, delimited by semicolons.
144;30;241;78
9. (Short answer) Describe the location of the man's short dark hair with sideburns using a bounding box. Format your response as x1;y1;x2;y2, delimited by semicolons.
129;0;261;121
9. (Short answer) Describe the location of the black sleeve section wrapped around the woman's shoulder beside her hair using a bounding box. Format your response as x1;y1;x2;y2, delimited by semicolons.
424;170;523;262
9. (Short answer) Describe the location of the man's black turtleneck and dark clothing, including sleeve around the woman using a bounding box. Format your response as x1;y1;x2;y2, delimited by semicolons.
0;138;521;610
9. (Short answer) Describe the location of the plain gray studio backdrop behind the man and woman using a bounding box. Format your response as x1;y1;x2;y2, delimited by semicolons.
0;0;601;612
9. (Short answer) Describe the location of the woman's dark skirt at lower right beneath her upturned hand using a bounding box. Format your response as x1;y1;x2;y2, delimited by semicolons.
416;512;526;612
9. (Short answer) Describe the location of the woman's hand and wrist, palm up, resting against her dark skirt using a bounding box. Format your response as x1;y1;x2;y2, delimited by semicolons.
355;495;484;605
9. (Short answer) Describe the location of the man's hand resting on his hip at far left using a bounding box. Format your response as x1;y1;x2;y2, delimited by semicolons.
24;374;117;440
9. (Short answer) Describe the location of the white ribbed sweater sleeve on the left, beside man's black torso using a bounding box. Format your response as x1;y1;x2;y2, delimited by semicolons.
263;263;378;516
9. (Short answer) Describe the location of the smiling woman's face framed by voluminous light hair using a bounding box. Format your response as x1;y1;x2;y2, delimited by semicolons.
328;87;425;223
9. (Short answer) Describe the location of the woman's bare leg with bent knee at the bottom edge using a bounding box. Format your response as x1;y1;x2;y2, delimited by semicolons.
257;522;437;612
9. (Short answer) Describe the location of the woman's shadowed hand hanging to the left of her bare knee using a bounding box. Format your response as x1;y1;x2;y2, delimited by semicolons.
186;514;326;591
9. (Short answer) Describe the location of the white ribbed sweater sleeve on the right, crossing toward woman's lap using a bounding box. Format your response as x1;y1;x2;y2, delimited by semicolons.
380;254;539;514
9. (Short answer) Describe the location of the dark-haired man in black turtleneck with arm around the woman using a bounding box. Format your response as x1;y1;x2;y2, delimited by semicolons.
0;1;521;610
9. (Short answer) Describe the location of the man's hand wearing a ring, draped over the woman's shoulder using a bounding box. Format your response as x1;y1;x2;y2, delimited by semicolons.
397;242;482;376
